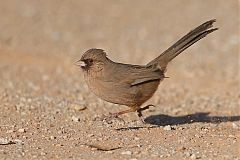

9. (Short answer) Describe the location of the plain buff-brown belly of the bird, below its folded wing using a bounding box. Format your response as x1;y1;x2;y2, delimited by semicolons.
87;79;160;107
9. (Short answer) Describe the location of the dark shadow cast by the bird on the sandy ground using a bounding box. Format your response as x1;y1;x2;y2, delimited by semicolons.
117;112;240;130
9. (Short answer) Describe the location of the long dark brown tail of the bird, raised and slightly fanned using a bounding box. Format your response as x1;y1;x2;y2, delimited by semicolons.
147;19;218;71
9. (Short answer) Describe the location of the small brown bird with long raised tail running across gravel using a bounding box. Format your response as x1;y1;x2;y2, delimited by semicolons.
76;20;218;121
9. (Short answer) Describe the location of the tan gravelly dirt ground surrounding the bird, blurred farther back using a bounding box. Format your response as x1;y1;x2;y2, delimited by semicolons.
0;0;240;160
